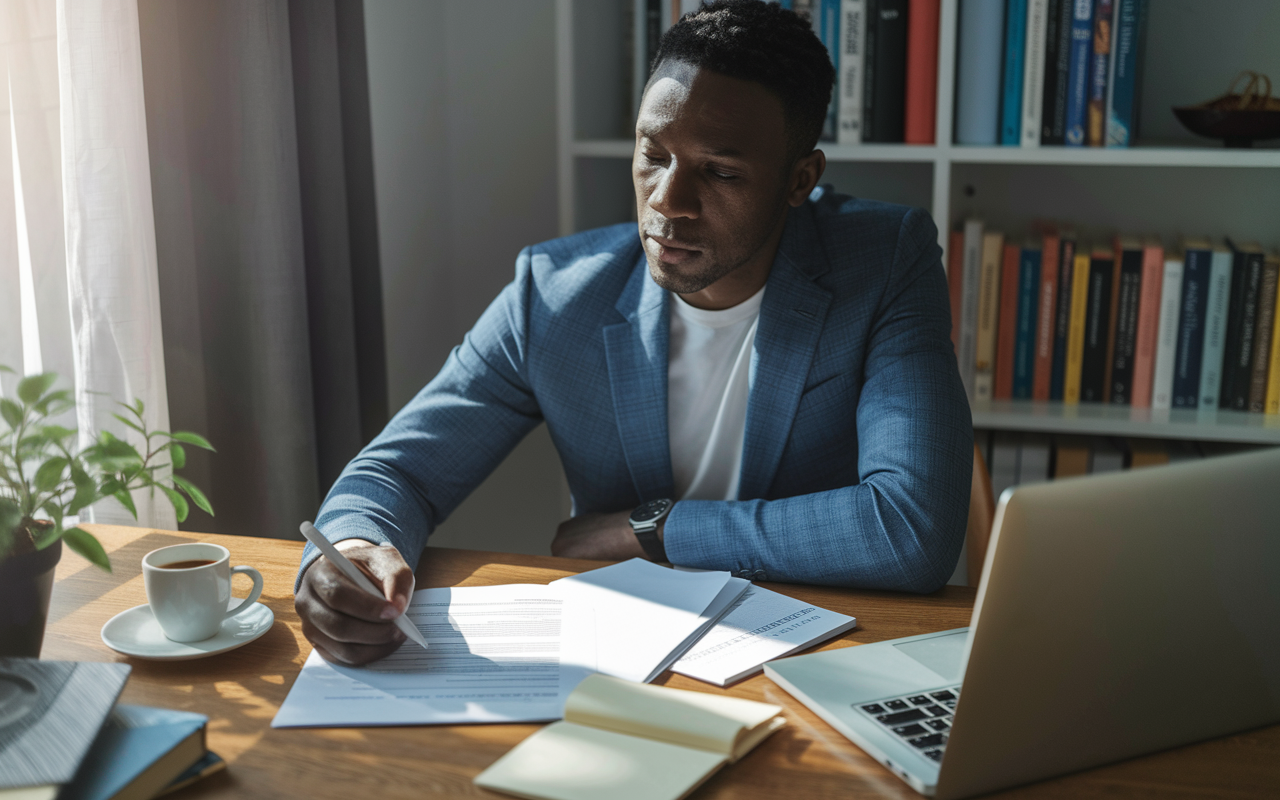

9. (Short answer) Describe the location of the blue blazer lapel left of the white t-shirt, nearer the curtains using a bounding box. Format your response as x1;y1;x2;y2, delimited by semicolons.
604;252;675;502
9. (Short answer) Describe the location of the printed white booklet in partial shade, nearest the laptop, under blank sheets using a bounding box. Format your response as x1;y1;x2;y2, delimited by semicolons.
671;586;858;686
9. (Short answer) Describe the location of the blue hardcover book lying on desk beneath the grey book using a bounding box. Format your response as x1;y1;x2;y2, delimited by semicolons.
58;705;209;800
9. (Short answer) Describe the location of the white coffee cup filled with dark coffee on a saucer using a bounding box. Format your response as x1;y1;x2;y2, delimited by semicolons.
142;541;262;641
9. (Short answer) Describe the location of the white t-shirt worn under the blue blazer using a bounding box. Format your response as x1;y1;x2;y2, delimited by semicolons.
667;287;764;500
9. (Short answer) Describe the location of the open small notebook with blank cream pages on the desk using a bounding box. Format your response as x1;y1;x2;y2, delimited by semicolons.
475;675;786;800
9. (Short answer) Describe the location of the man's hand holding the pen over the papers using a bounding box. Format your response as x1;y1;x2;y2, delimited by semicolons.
293;539;413;666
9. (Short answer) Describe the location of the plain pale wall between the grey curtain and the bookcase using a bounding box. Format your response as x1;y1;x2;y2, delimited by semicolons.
365;0;568;553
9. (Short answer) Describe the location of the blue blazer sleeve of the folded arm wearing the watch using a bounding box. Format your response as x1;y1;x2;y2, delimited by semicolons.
663;209;973;593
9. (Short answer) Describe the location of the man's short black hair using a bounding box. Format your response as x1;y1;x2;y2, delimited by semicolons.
649;0;836;157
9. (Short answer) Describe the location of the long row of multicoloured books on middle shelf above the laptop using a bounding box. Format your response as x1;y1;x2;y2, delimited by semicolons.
947;219;1280;413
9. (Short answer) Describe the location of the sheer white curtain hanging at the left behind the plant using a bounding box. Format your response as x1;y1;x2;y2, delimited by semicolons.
0;0;177;529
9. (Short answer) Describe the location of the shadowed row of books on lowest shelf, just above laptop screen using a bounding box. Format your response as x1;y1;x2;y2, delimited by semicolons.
975;430;1253;500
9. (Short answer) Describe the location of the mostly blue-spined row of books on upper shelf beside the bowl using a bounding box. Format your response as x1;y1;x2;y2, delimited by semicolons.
956;0;1147;147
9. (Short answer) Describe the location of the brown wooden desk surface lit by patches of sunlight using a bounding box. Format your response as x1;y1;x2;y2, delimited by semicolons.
41;526;1280;800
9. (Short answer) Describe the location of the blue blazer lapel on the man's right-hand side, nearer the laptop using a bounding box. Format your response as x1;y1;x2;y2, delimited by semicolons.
737;204;831;499
